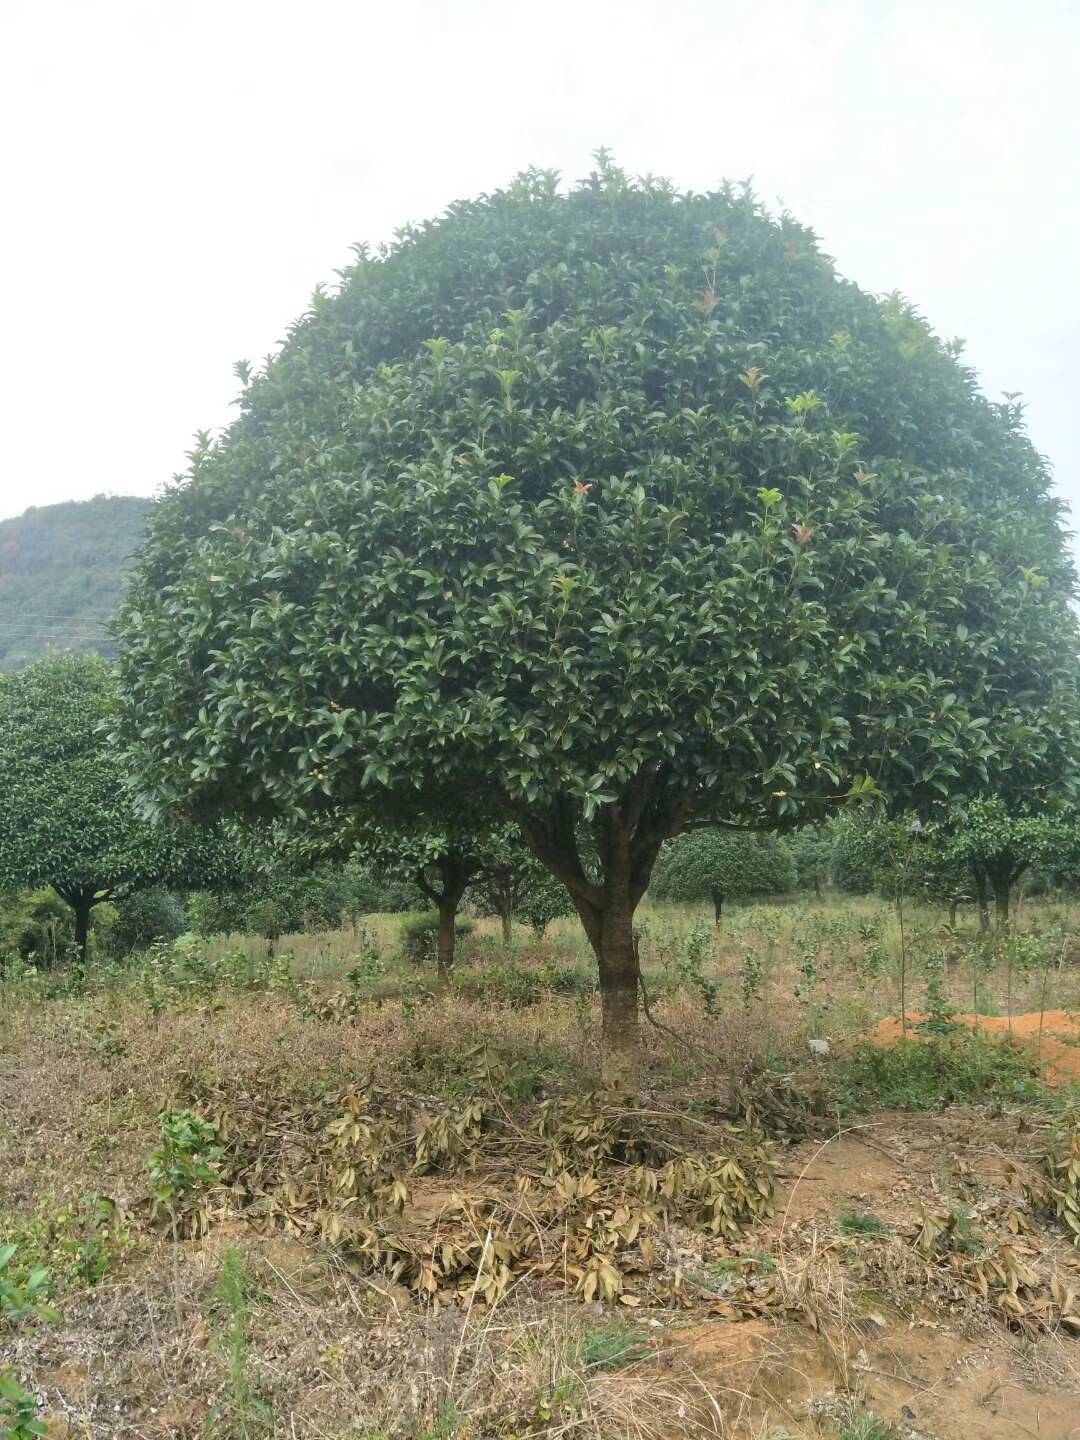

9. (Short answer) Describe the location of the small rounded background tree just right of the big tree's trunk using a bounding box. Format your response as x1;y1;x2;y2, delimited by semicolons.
649;829;795;924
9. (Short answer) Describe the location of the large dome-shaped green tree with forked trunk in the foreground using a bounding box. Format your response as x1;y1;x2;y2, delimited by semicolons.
120;158;1074;1079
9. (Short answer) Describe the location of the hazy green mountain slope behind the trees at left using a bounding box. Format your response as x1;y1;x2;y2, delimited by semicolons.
0;495;151;671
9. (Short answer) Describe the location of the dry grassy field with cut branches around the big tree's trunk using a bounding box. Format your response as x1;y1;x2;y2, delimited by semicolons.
0;897;1080;1440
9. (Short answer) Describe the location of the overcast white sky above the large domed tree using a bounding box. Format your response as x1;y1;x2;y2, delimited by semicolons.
0;0;1080;541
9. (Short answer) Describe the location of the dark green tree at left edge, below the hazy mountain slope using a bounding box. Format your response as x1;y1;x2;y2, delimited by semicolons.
0;655;230;960
